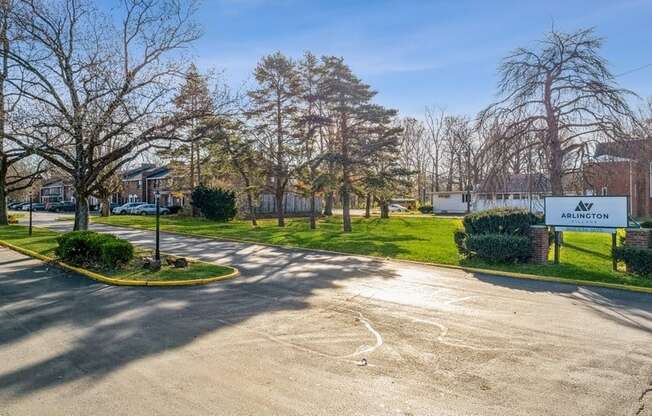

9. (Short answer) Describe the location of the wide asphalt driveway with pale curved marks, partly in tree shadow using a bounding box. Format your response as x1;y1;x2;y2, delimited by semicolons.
0;215;652;416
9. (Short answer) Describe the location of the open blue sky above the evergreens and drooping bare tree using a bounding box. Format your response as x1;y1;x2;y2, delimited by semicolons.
185;0;652;118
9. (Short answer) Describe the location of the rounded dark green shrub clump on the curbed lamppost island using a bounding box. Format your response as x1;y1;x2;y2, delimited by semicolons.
54;231;134;267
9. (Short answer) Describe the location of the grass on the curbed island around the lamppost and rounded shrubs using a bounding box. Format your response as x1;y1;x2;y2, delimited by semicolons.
0;225;233;281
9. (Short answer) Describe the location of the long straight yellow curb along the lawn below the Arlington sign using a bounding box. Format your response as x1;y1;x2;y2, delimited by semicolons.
91;222;652;294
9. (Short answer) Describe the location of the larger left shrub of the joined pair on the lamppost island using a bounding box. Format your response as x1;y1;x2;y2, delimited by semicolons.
55;231;118;264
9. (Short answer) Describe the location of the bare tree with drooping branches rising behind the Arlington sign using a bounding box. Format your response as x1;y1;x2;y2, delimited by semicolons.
480;29;632;195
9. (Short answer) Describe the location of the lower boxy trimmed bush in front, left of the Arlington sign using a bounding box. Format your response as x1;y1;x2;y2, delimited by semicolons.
464;234;531;263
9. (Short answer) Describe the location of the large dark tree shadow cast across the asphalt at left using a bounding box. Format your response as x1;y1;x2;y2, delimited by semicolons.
0;237;396;396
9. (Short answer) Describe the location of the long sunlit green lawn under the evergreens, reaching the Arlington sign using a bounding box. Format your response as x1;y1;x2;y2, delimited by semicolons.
92;216;652;287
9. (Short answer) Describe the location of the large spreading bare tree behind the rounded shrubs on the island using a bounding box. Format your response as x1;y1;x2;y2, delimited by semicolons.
7;0;199;229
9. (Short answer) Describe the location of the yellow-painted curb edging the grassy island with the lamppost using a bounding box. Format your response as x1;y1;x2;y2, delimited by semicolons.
0;240;240;286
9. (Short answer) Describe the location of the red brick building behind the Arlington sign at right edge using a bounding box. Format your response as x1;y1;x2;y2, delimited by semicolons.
583;139;652;217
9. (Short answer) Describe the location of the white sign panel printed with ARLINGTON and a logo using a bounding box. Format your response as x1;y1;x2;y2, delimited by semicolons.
545;196;628;228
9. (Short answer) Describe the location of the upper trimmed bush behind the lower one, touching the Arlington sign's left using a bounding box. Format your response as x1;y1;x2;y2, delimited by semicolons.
463;208;543;235
